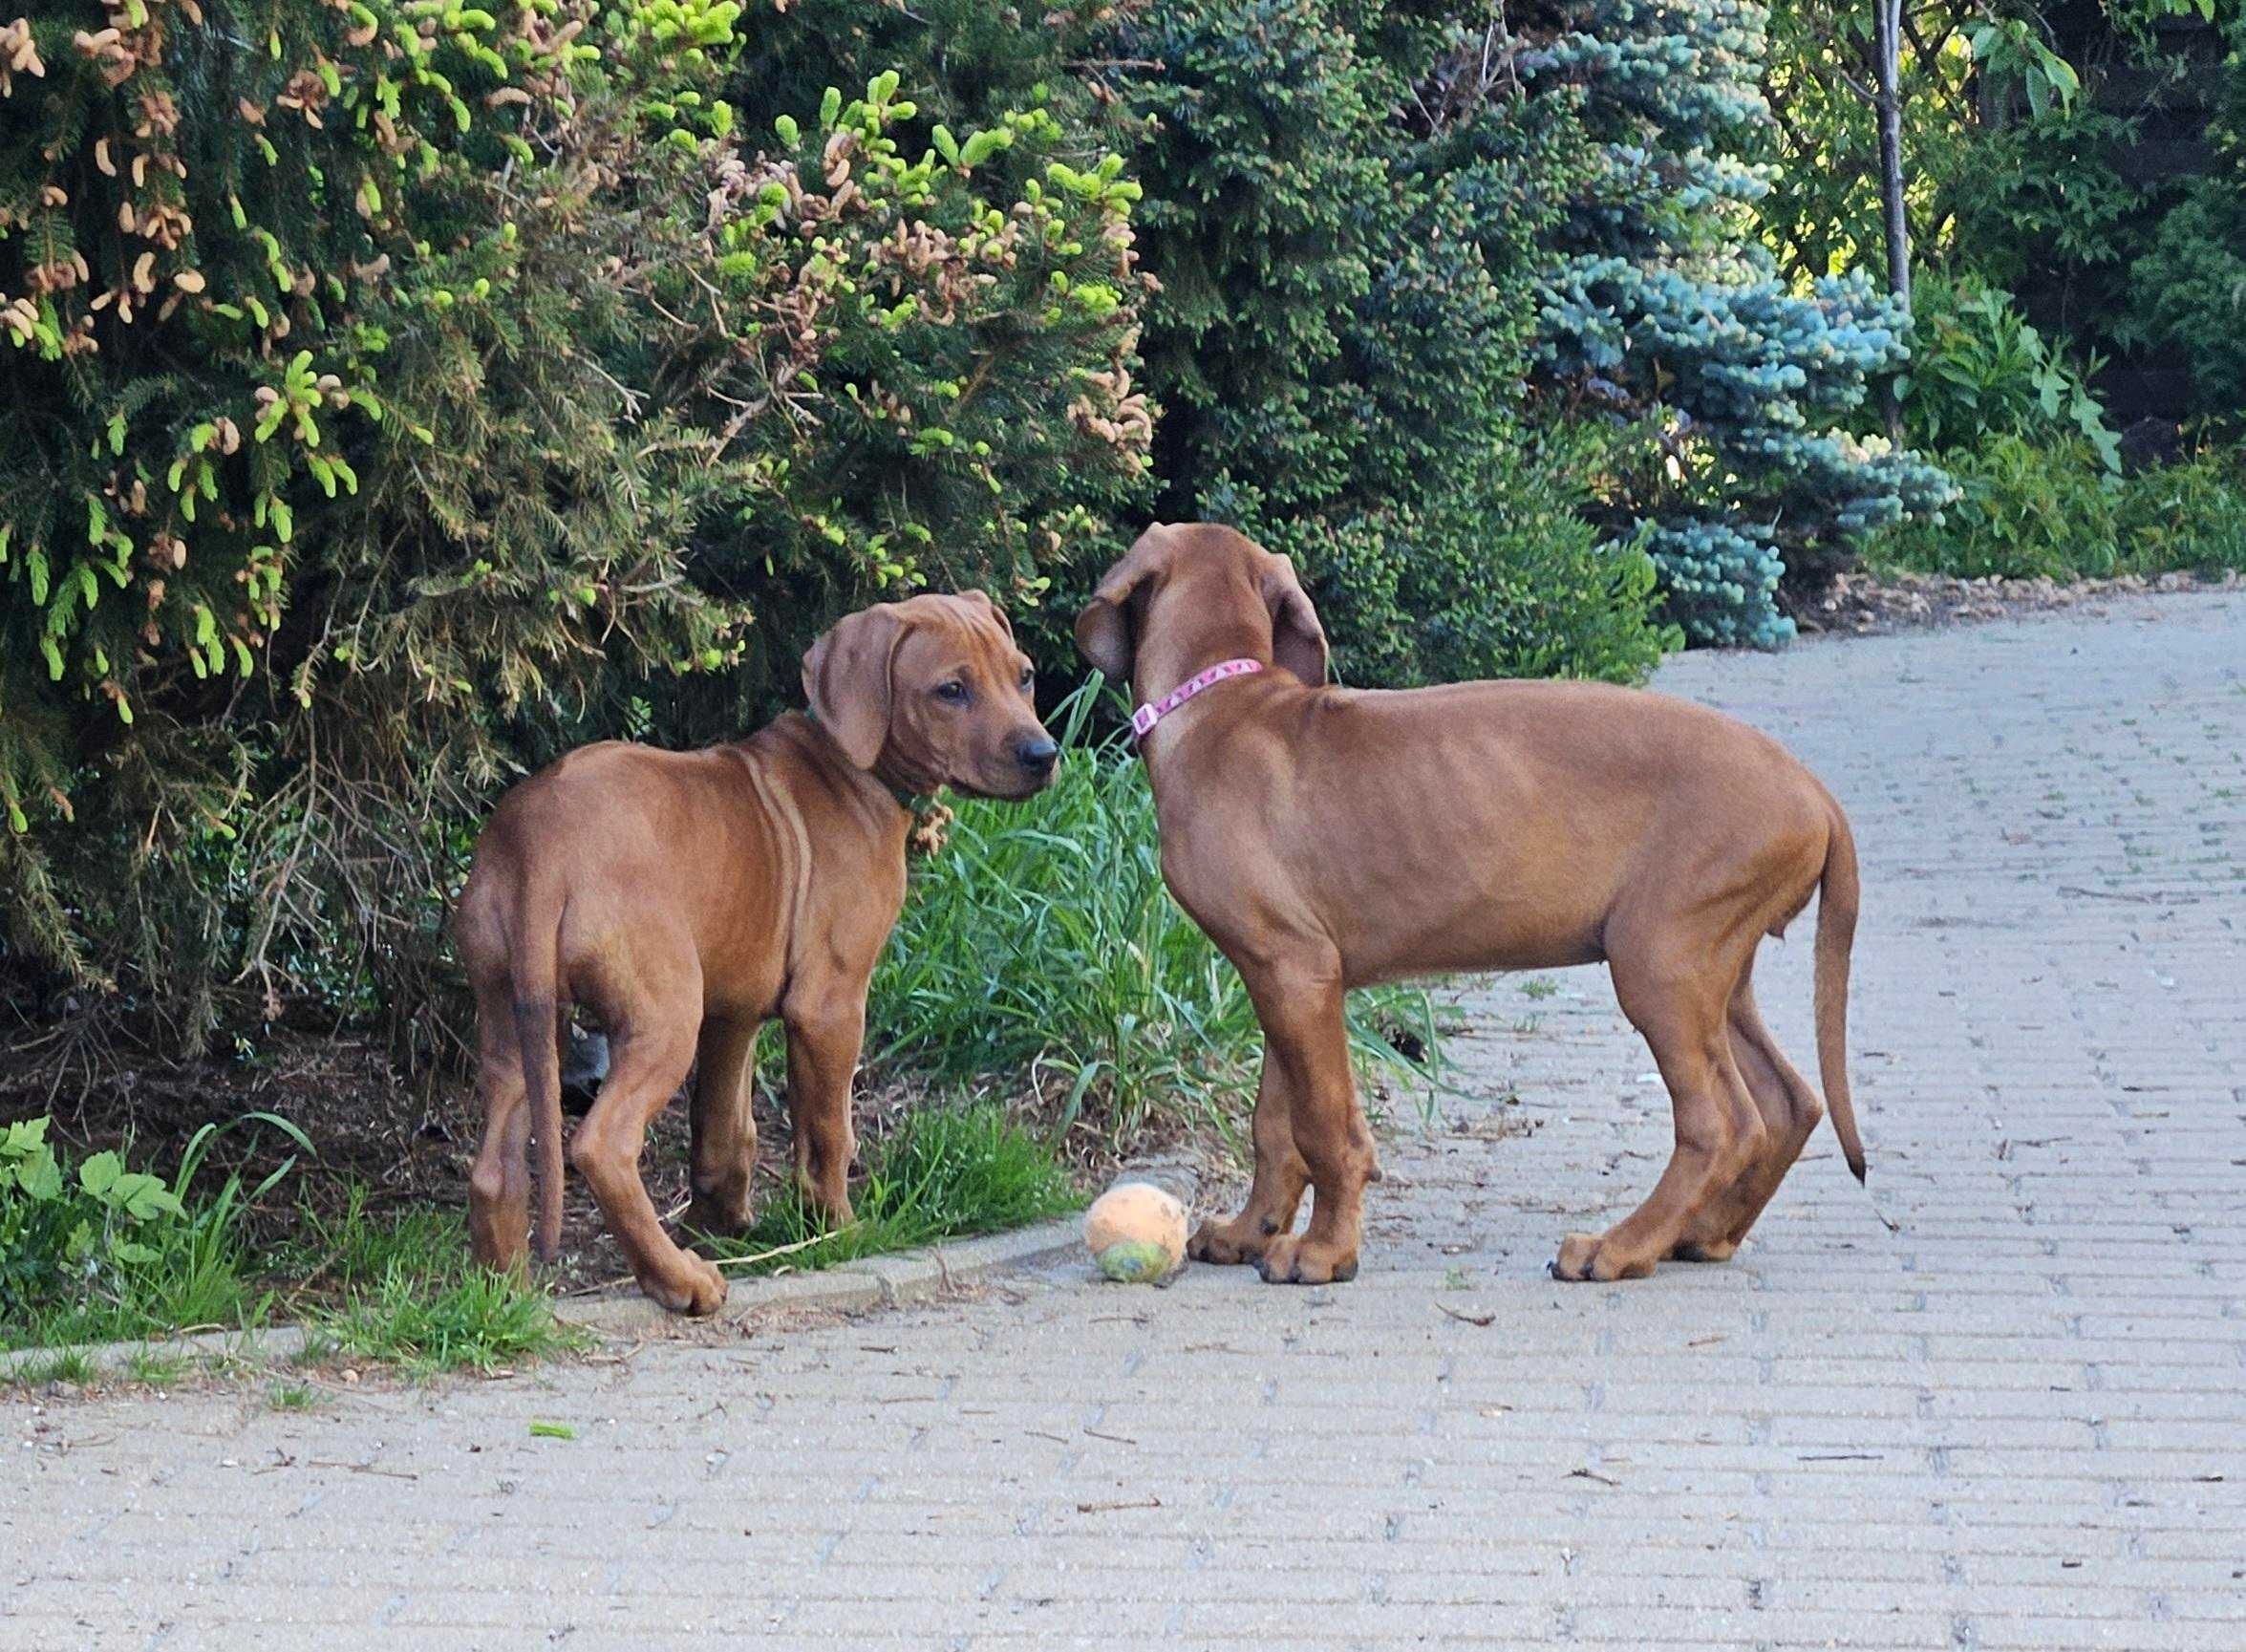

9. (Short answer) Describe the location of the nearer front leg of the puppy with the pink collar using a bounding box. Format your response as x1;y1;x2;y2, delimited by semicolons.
1242;955;1375;1286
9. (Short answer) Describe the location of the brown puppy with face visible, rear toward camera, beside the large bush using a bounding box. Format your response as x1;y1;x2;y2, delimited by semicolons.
454;591;1058;1313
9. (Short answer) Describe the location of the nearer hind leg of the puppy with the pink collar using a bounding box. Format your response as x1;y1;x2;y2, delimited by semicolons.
1552;946;1767;1279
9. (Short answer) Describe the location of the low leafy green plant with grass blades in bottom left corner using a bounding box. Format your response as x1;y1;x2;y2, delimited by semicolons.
0;1112;310;1348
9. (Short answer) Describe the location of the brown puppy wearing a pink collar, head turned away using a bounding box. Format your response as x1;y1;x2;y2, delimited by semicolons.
1076;524;1864;1283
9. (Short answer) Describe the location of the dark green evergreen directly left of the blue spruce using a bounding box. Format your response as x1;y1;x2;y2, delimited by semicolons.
1116;0;1676;685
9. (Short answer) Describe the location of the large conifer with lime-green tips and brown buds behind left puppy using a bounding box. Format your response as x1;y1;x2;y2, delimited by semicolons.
0;0;1150;1057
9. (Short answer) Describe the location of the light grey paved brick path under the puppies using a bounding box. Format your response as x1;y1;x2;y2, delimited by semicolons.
0;598;2246;1652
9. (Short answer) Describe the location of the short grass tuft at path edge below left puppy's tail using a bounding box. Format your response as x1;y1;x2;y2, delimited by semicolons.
294;1189;577;1378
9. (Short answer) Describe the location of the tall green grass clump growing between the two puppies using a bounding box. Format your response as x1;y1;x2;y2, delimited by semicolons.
866;676;1440;1150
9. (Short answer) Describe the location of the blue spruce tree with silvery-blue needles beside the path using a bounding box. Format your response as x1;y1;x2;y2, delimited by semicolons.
1516;0;1952;647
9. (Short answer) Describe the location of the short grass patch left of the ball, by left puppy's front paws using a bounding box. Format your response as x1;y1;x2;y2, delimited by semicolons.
705;1102;1085;1279
